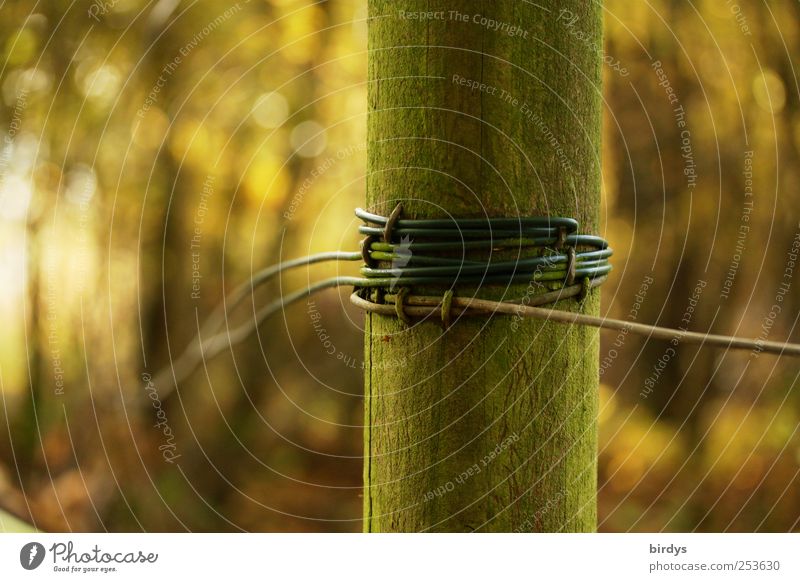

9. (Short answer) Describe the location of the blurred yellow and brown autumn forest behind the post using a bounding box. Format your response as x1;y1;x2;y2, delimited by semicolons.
0;0;800;531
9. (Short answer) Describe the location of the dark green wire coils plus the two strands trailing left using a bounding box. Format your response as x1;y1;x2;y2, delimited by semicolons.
156;208;612;388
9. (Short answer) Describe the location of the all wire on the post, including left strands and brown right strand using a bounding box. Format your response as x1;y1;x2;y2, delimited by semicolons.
154;205;800;398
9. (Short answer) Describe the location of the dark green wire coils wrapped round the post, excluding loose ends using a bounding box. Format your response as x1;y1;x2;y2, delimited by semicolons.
356;206;612;288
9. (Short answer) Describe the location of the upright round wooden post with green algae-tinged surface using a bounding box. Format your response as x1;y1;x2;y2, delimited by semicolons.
364;0;602;532
